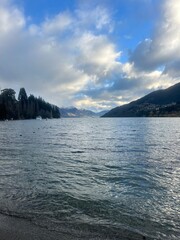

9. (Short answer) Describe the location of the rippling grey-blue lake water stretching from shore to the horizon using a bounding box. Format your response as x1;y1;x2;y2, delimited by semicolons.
0;118;180;239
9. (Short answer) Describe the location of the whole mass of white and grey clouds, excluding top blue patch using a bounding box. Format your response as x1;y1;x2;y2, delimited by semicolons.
0;0;180;109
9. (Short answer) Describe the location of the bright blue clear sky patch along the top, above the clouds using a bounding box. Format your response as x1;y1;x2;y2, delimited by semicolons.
14;0;160;61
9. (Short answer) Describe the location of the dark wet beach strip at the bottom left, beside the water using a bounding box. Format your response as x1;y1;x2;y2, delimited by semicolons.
0;213;148;240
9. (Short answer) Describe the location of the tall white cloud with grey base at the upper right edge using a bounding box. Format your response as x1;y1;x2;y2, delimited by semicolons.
130;0;180;75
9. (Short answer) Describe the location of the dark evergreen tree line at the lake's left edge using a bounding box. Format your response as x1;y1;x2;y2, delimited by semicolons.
0;88;60;120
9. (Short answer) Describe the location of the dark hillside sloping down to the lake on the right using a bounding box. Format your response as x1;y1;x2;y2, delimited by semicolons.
102;83;180;117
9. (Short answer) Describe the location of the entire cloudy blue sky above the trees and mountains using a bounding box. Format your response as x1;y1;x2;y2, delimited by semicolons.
0;0;180;111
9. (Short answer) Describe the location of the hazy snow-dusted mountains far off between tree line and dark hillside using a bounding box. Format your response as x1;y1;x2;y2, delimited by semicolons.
59;107;108;118
